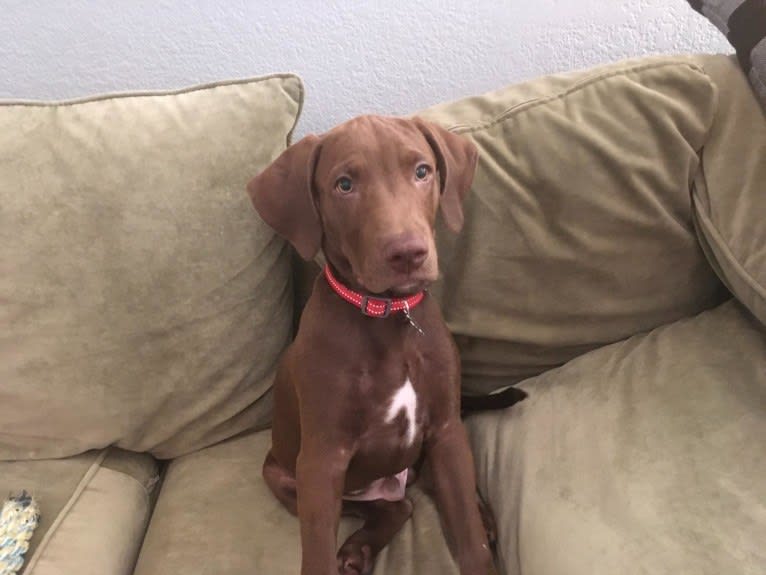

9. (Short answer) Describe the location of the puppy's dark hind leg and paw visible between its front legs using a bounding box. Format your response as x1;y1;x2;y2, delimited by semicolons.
338;497;413;575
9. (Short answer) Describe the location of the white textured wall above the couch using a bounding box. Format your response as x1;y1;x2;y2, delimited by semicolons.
0;0;730;133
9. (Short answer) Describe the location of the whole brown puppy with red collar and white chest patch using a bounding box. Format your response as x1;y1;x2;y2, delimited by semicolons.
248;116;504;575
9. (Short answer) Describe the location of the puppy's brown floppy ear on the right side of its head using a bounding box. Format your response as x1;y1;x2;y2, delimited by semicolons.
414;118;479;232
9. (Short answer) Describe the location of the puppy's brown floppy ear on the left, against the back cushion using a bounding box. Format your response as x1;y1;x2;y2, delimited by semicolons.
247;135;322;260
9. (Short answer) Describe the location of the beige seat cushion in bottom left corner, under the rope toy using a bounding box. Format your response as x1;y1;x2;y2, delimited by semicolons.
0;448;158;575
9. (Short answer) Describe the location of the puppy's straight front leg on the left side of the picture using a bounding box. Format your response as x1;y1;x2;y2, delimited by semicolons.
295;444;350;575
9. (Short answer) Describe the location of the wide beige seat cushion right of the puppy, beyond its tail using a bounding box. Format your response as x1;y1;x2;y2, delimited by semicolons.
468;301;766;575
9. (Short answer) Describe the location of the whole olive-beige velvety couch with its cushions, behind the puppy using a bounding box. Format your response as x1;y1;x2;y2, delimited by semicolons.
0;56;766;575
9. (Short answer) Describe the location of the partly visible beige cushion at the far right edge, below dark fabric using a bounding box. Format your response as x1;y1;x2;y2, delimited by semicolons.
693;55;766;324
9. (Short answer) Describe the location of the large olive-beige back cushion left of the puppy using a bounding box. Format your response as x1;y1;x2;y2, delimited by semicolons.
0;76;302;459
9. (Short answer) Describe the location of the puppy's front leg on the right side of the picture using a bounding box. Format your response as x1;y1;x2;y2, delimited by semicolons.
426;418;497;575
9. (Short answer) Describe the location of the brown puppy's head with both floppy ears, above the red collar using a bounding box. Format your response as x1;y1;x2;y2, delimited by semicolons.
247;116;477;295
